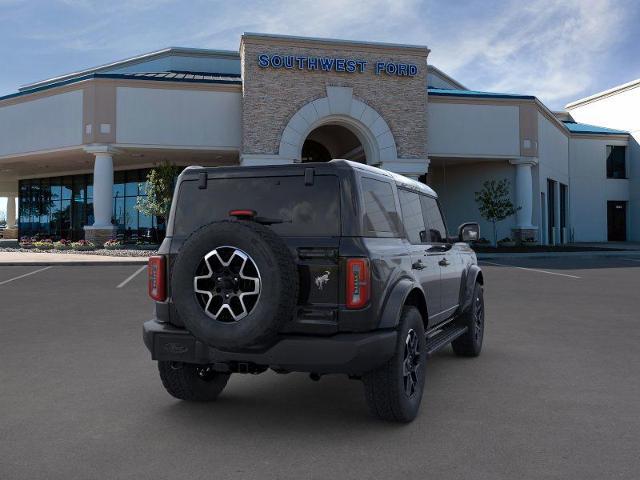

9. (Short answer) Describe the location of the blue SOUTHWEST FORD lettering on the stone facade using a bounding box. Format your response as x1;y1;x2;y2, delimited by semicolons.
258;53;418;77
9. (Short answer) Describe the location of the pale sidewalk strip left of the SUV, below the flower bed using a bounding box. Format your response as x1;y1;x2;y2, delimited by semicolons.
0;252;148;267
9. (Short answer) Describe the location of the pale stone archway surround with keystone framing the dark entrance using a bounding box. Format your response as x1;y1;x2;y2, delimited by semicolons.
278;86;398;165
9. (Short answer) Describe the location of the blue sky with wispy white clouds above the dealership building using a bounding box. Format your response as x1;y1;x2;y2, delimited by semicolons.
0;0;640;109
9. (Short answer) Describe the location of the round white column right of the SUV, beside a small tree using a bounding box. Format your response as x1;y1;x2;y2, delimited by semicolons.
509;157;538;240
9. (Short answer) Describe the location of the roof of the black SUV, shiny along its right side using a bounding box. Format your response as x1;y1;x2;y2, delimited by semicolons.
183;159;438;198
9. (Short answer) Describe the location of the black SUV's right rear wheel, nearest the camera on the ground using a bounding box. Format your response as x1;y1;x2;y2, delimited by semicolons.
362;306;426;422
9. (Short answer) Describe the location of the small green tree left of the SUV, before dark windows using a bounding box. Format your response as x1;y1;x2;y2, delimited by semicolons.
136;161;181;220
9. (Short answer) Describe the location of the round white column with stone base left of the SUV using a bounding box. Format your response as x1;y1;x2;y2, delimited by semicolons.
84;145;116;245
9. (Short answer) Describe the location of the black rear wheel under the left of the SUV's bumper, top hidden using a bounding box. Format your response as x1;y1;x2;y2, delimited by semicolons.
158;362;230;402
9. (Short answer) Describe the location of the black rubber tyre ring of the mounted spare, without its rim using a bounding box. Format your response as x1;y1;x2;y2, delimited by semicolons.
171;220;299;351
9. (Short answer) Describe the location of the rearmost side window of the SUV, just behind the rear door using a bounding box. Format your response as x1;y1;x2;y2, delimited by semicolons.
362;177;399;236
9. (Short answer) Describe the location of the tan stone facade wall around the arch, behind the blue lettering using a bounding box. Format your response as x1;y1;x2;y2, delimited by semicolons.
240;34;429;159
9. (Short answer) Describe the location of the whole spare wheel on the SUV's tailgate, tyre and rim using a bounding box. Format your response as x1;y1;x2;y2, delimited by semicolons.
171;220;298;350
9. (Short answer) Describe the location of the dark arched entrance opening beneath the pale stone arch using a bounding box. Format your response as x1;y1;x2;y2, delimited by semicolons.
300;123;367;163
